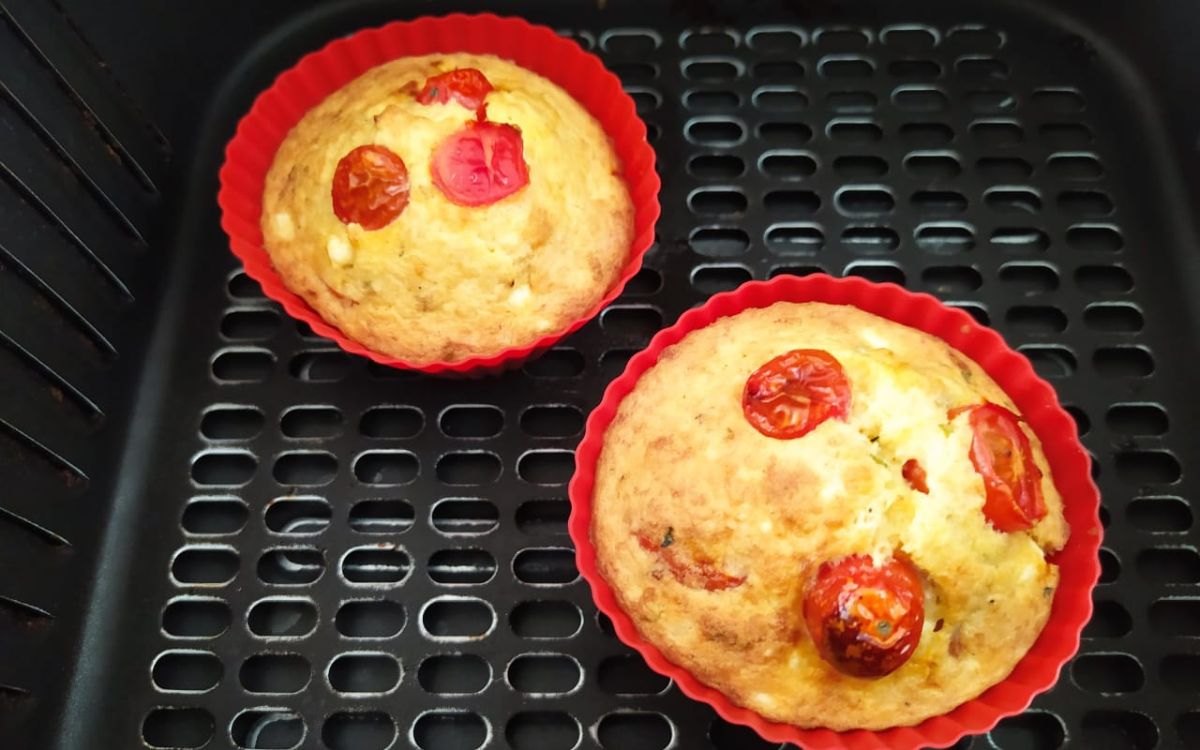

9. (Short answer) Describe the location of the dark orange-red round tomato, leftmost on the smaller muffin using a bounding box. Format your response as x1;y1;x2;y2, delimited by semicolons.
330;145;408;230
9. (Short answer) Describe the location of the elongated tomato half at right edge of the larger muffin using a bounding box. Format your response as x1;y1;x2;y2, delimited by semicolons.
949;402;1046;532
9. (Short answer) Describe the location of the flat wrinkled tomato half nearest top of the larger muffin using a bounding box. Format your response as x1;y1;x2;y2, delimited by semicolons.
742;349;850;439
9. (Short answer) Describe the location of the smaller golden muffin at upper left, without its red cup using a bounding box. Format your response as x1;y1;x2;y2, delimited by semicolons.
262;54;634;365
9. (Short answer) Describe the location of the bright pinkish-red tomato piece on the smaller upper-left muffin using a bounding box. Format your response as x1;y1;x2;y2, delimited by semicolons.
431;122;529;205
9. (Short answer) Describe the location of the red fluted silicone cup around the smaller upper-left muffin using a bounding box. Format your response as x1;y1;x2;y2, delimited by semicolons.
217;14;660;374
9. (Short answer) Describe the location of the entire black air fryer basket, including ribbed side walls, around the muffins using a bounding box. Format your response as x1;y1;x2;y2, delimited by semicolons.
0;0;1200;750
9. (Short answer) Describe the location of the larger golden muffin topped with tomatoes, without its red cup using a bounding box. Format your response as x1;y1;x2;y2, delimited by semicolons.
592;302;1068;731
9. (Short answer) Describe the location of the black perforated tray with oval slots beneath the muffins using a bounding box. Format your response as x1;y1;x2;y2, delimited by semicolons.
108;13;1200;750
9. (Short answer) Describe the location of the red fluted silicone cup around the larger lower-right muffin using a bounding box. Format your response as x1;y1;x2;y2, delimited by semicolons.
569;275;1102;750
